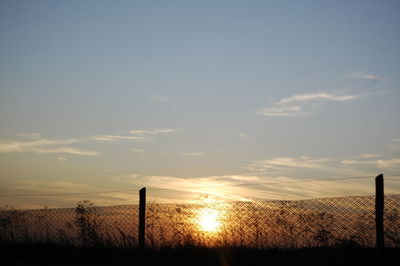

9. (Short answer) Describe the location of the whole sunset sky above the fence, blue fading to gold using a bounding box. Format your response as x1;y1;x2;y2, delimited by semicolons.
0;0;400;208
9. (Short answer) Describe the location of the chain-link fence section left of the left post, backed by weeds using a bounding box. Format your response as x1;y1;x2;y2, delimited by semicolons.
0;201;138;247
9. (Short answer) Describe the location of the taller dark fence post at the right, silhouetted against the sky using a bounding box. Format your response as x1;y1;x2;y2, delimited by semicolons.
375;174;385;256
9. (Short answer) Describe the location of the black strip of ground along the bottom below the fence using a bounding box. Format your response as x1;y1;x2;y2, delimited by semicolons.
0;245;400;266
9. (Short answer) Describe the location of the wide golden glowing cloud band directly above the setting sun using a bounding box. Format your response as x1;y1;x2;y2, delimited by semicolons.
113;174;382;202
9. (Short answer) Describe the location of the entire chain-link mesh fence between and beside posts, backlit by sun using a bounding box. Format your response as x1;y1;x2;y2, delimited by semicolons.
0;194;400;249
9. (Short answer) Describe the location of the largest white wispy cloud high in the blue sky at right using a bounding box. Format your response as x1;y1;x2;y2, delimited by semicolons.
256;92;360;117
